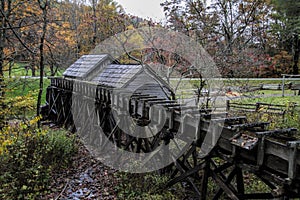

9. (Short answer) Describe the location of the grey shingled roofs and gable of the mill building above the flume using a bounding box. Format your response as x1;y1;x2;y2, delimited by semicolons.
63;54;172;98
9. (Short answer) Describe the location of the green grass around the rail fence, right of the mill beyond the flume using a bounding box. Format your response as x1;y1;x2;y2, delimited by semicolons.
176;79;300;130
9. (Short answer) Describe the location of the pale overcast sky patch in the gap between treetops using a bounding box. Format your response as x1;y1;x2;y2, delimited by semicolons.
115;0;165;21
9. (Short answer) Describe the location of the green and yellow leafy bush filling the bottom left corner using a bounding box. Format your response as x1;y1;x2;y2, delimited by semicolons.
0;118;76;199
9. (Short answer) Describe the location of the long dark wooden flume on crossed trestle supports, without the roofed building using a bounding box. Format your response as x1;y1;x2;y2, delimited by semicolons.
43;78;300;199
